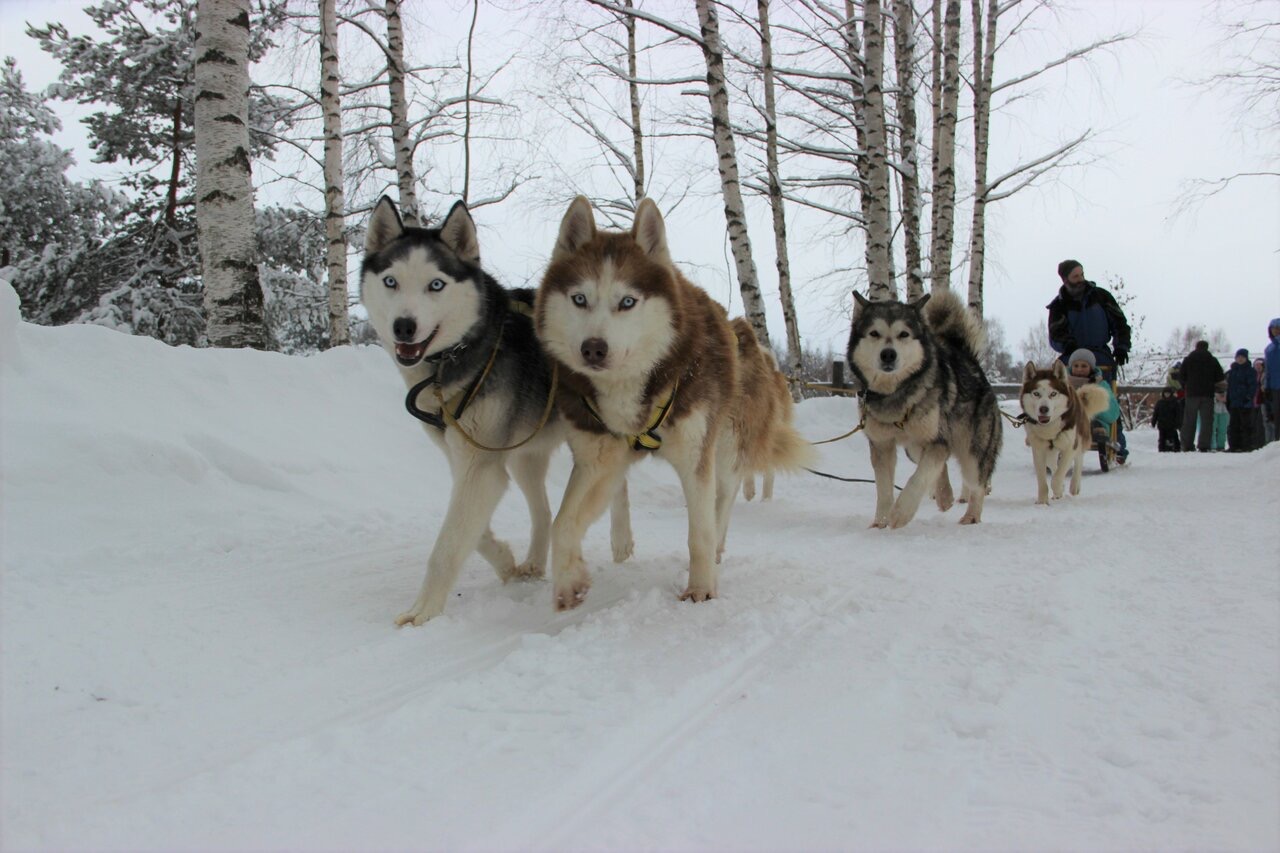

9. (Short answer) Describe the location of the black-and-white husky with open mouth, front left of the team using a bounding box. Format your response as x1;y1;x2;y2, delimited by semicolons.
360;196;631;625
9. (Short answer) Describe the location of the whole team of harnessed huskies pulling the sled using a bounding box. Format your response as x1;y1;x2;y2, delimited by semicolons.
360;197;1105;625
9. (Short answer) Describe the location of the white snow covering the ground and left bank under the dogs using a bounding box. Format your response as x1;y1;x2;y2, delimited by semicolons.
0;277;1280;850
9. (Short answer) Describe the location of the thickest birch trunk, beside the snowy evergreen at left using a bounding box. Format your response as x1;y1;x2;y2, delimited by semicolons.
195;0;266;348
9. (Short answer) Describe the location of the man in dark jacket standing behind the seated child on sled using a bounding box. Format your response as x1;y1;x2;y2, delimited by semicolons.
1047;260;1130;465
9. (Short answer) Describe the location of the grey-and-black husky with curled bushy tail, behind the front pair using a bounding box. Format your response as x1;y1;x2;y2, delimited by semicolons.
846;291;1004;528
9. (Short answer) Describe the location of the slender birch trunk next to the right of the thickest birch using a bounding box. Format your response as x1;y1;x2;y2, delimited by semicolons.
320;0;350;347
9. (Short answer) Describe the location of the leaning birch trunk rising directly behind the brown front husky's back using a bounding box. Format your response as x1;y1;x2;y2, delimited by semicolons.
694;0;769;348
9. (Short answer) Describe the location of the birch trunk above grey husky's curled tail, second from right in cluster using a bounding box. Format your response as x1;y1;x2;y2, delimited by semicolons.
929;0;960;291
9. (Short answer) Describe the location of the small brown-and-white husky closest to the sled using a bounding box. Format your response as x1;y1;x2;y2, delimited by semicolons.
1021;360;1111;503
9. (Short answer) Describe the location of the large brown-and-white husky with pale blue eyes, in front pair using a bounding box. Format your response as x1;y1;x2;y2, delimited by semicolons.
536;196;809;610
